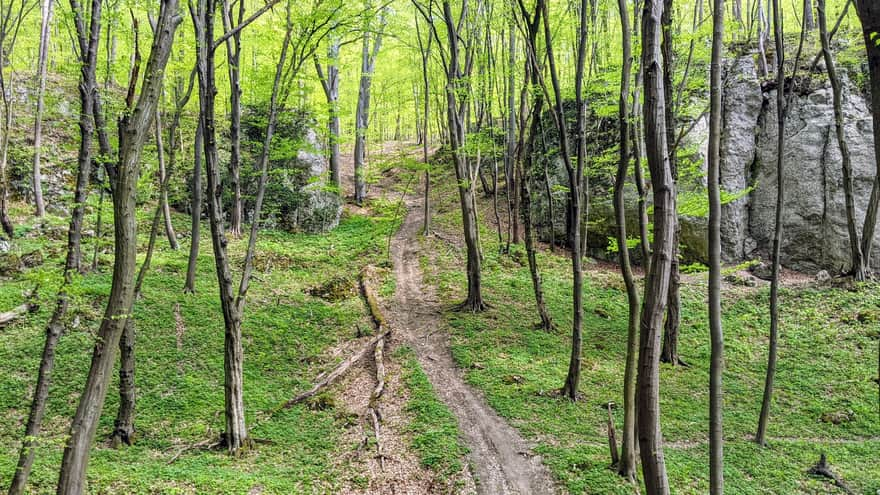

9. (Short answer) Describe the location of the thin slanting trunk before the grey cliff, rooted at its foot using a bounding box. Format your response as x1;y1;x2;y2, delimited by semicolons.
817;0;866;281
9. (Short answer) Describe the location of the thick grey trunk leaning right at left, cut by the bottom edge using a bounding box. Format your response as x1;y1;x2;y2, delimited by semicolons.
58;0;180;495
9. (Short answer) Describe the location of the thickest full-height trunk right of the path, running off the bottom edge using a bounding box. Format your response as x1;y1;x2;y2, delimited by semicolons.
636;0;676;495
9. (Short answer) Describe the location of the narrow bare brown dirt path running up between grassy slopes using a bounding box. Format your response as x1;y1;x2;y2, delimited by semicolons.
389;196;556;495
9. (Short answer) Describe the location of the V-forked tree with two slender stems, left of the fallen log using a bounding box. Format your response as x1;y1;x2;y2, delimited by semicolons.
190;0;341;456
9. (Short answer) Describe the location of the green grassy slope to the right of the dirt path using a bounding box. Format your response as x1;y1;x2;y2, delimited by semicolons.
423;170;880;494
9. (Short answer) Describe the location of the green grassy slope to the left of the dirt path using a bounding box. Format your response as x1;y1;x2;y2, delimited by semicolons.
0;195;457;493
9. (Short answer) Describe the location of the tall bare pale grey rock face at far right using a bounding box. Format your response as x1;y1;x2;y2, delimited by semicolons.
722;59;880;271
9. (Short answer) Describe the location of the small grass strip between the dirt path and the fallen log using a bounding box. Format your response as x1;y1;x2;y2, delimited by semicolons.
394;347;468;478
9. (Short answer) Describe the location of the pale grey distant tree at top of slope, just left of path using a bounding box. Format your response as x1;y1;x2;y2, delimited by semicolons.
354;0;387;205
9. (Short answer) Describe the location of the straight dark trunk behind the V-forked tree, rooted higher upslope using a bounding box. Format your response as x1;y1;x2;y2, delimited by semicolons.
222;0;245;239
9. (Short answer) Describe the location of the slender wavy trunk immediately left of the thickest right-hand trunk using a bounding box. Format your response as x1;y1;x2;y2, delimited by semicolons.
614;0;639;482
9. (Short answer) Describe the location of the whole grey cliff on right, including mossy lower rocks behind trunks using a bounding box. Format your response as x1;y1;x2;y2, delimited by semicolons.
534;57;880;272
